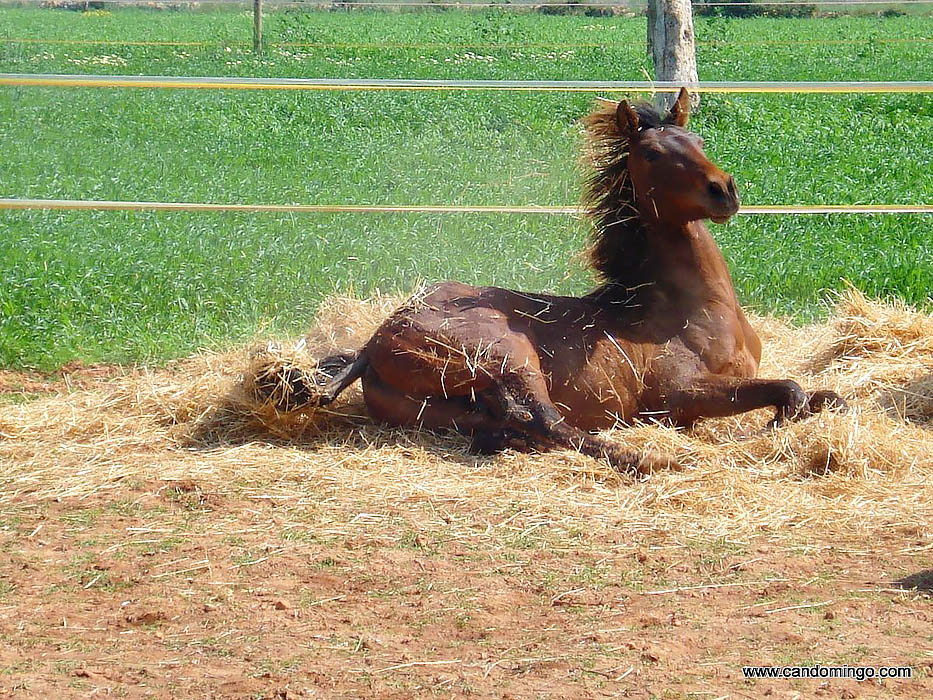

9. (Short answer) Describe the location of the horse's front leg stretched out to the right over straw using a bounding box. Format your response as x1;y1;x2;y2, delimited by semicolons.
664;375;847;427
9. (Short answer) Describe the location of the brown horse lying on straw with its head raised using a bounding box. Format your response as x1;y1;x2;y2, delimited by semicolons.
274;90;845;470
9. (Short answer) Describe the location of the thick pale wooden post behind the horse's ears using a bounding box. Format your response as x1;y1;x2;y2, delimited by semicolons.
648;0;700;108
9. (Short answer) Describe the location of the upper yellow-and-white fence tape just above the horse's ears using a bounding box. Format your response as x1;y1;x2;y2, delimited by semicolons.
0;73;933;93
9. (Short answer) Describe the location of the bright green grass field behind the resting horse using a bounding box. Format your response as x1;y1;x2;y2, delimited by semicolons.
0;7;933;369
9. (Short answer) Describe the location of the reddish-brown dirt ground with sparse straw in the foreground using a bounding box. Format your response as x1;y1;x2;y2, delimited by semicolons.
0;474;933;698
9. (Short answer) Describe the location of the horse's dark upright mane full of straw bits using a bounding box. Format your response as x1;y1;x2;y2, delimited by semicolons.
583;102;668;295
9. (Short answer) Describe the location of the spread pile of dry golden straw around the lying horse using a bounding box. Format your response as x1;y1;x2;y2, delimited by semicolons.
0;290;933;538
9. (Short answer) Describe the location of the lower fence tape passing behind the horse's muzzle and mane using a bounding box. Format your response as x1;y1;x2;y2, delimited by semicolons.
0;199;933;216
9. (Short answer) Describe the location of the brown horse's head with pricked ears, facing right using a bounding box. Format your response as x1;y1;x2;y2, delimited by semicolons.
616;88;739;224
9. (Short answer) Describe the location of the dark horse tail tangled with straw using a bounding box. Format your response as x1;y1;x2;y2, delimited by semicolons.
254;351;369;412
